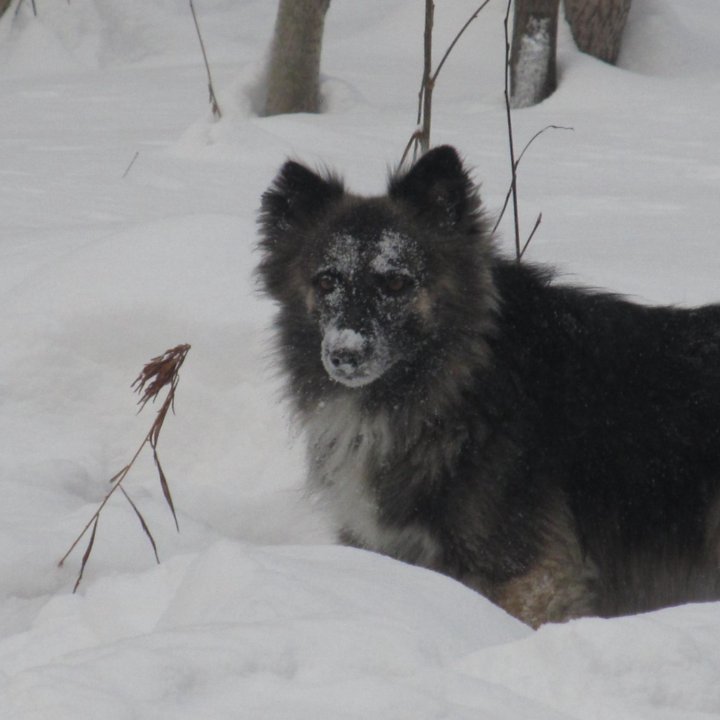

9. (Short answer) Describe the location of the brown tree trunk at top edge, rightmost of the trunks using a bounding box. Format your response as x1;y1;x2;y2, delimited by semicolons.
565;0;631;65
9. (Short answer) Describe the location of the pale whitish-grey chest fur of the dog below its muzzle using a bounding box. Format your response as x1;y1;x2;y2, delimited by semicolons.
306;396;440;568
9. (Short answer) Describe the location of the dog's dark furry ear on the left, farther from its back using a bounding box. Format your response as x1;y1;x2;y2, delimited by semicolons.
260;160;344;233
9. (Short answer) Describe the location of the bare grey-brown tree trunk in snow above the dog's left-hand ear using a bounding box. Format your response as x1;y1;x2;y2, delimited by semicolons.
264;0;330;115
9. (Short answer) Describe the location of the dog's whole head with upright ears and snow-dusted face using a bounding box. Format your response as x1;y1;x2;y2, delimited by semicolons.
259;146;492;388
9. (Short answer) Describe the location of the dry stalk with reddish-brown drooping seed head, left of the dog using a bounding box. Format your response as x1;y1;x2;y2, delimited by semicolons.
58;345;190;592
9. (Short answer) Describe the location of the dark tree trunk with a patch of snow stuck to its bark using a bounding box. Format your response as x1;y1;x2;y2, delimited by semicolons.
510;0;560;107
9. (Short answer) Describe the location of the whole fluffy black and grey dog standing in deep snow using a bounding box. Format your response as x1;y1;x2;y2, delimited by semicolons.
259;147;720;626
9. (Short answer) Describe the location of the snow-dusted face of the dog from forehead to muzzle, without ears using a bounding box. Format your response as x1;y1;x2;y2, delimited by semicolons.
306;222;424;387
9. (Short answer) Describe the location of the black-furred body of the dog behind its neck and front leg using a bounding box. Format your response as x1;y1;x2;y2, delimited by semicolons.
493;263;720;614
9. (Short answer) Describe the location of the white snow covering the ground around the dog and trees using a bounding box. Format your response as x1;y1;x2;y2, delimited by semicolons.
0;0;720;720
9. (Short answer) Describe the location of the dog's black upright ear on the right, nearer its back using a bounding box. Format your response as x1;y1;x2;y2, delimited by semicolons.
388;145;479;225
